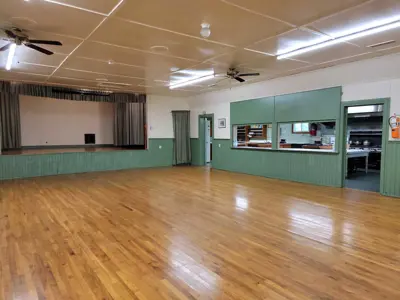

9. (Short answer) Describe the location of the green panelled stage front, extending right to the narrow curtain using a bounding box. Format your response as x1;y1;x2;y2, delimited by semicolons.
0;139;173;180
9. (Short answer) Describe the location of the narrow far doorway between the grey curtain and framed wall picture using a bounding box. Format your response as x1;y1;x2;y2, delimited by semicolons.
199;114;214;166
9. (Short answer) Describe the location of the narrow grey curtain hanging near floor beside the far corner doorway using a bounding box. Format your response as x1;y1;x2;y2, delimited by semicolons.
172;111;192;165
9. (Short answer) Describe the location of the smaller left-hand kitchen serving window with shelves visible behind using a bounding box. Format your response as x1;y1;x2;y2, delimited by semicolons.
233;124;272;148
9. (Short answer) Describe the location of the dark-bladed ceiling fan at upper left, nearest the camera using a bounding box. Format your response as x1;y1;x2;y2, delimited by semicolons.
0;28;62;55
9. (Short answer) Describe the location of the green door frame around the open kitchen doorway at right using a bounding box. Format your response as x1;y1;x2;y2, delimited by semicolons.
339;98;390;195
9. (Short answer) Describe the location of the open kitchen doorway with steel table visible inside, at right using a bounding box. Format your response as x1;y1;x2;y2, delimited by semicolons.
343;99;389;192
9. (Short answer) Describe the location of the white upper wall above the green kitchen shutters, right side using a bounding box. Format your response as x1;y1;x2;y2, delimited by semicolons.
188;54;400;139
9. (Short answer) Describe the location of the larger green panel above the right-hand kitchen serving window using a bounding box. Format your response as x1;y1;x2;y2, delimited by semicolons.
275;87;342;122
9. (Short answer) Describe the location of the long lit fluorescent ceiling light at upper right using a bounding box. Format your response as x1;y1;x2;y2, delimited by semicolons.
277;21;400;59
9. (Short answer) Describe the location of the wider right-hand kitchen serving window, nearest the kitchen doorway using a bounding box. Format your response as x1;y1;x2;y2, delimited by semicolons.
278;121;336;151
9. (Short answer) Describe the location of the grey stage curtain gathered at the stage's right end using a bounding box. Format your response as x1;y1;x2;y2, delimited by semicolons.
114;103;146;147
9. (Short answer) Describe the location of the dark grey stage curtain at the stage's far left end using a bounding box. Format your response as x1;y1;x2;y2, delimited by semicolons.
0;93;21;150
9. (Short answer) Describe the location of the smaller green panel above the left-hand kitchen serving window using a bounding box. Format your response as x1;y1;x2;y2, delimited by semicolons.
230;97;274;125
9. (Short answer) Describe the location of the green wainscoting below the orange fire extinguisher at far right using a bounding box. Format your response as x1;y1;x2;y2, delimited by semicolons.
381;142;400;197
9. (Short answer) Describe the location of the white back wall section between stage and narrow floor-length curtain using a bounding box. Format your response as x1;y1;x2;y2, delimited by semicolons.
147;95;190;138
